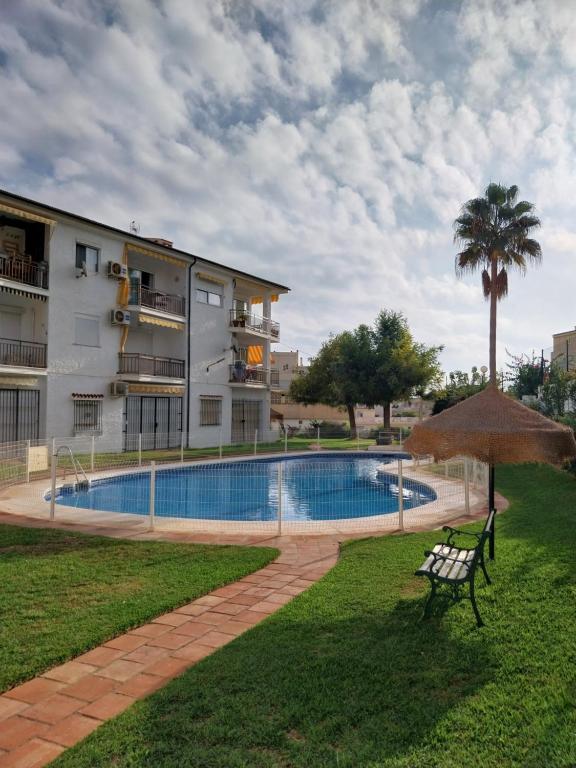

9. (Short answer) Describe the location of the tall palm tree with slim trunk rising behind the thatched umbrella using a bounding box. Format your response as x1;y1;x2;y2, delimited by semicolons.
454;184;542;384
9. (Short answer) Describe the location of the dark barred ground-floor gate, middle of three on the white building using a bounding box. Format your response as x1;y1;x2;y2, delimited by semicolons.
124;395;182;451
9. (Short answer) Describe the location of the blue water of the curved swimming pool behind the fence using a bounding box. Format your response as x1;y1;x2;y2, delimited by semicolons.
56;453;436;521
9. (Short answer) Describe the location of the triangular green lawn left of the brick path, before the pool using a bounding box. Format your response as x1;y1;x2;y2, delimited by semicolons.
0;525;276;690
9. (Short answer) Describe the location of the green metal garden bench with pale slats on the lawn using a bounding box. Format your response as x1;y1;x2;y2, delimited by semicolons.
415;510;494;627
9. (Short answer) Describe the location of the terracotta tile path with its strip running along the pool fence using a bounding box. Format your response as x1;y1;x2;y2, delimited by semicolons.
0;492;505;768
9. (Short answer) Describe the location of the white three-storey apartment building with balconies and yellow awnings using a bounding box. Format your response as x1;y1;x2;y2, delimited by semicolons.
0;191;288;450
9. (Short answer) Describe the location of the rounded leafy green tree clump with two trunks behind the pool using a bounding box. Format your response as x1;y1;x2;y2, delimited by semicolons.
290;312;441;437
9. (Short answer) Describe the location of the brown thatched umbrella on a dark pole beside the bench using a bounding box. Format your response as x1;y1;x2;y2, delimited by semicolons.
404;384;576;559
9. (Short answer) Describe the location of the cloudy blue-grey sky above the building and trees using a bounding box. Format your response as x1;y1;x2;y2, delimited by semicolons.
0;0;576;370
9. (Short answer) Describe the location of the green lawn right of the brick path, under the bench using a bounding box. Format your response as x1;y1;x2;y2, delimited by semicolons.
56;460;576;768
